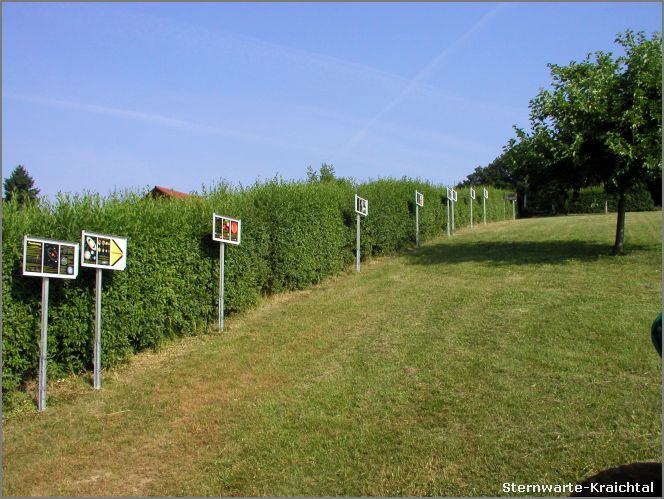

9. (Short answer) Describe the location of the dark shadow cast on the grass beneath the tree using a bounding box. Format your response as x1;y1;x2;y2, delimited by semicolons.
409;239;650;265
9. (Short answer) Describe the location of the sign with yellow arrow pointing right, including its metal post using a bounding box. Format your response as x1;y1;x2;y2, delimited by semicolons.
81;231;127;390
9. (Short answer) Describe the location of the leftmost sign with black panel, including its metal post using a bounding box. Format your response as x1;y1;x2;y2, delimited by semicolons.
23;236;78;412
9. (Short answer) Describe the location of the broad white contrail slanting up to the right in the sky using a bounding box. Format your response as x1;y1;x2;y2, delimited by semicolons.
337;4;505;162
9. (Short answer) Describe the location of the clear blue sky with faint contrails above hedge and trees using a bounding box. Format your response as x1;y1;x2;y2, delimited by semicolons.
2;2;662;197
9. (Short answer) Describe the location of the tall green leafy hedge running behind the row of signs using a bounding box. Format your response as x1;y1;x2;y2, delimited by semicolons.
2;179;504;396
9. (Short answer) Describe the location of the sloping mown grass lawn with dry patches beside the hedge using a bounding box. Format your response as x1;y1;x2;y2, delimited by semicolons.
2;212;662;496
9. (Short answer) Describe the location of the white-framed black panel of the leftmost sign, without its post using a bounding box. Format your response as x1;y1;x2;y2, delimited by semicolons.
23;236;78;279
